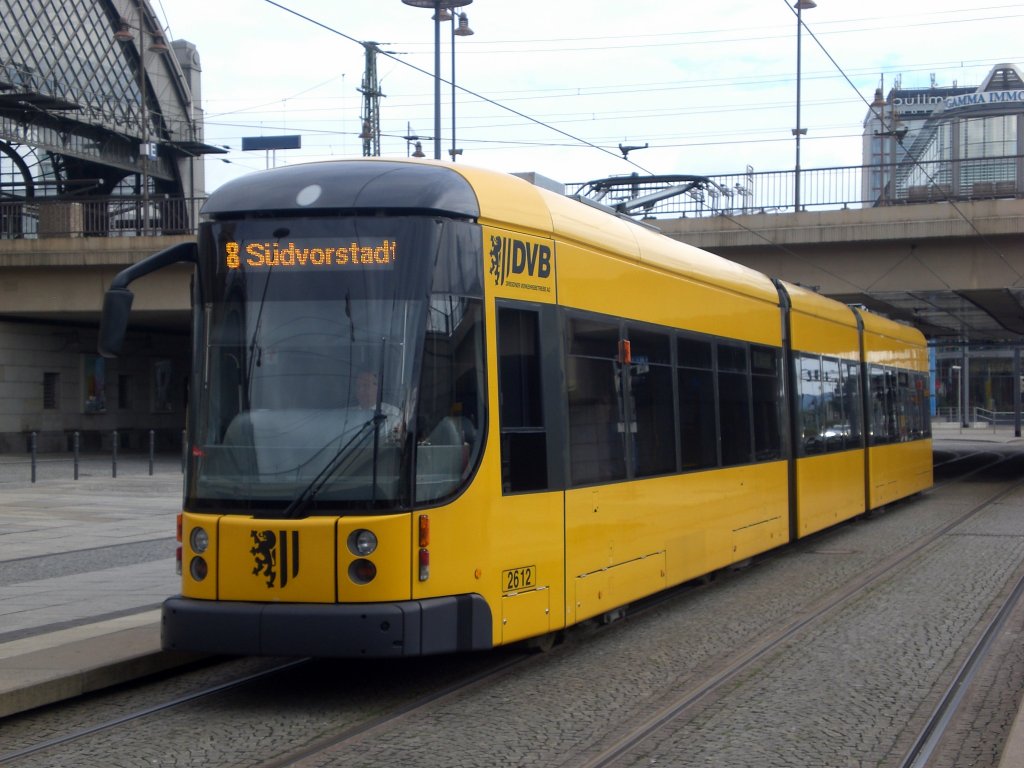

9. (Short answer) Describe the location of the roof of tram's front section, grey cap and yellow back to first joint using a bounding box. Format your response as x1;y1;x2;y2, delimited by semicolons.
202;158;778;304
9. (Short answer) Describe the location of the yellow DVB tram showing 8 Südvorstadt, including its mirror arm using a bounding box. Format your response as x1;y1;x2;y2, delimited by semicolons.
100;160;932;656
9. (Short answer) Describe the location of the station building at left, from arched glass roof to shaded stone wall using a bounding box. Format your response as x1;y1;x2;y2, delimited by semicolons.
0;0;218;452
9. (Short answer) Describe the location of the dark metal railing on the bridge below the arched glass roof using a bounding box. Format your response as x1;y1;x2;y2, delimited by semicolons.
0;196;205;240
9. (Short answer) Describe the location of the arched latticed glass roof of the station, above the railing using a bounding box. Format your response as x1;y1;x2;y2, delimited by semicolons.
0;0;220;201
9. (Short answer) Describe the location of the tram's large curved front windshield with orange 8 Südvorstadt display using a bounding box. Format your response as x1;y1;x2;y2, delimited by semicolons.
186;217;484;516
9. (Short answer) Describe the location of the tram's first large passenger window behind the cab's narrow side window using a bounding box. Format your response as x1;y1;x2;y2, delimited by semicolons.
565;317;626;485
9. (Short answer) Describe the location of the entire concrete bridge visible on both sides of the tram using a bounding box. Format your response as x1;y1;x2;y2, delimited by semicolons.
0;199;1024;342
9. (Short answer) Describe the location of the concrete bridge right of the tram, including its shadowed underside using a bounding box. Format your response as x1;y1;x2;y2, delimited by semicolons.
651;199;1024;342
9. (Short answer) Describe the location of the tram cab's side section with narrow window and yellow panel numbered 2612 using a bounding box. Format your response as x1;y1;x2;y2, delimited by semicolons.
497;301;565;642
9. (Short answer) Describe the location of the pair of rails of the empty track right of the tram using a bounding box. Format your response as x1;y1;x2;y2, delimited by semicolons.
561;453;1024;768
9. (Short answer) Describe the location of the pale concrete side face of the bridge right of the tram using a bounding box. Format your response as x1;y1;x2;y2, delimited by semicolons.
653;200;1024;295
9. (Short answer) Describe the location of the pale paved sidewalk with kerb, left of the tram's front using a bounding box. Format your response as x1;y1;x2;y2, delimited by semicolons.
0;454;198;717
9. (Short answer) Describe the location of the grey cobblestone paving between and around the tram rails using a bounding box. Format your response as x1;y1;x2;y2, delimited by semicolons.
0;446;1024;768
